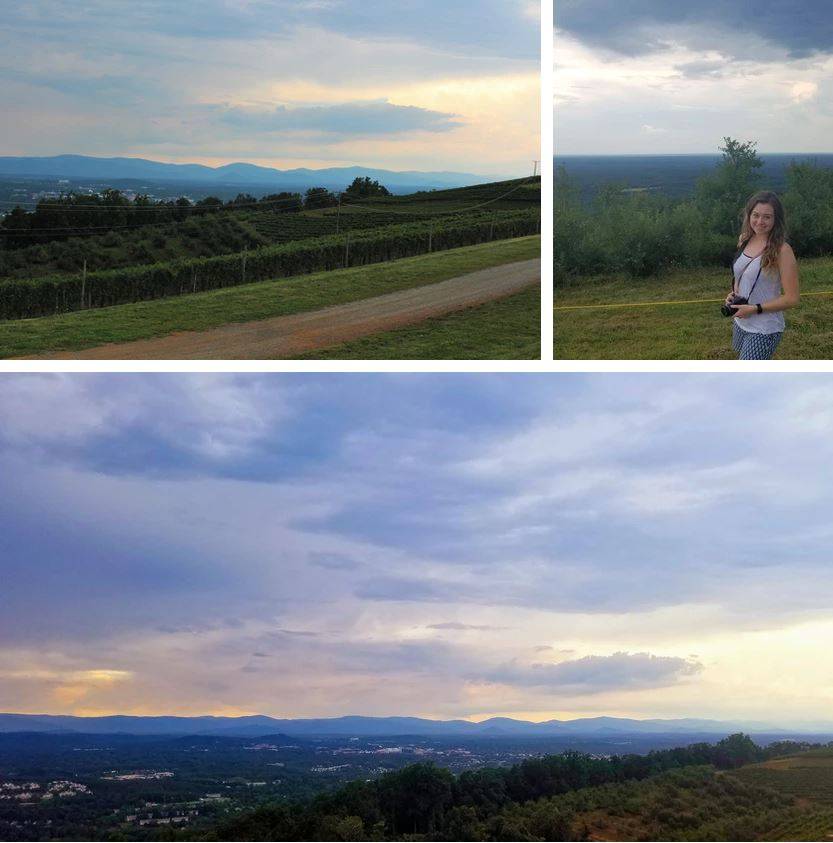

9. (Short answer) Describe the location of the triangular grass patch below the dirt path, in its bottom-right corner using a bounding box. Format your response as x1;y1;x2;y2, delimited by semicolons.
300;285;541;360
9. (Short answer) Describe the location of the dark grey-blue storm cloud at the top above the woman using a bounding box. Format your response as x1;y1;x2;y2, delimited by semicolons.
555;0;833;58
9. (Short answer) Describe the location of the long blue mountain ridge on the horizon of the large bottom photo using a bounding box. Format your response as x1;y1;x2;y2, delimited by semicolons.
0;714;802;737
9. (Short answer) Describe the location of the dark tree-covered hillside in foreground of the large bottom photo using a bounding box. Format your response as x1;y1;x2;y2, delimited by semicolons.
212;734;833;840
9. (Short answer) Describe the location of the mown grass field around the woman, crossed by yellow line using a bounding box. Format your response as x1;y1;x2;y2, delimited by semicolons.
554;258;833;360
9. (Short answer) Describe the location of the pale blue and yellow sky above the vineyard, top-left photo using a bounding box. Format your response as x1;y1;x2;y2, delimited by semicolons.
0;0;540;176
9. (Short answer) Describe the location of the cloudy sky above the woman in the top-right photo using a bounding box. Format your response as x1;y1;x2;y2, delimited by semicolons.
554;0;833;155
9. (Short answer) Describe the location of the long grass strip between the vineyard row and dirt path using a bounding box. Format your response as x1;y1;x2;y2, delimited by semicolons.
0;237;540;357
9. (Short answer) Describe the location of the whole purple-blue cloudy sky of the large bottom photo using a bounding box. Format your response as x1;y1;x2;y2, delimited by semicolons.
0;373;833;728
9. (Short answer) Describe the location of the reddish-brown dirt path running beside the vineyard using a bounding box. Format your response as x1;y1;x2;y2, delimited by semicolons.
44;258;541;360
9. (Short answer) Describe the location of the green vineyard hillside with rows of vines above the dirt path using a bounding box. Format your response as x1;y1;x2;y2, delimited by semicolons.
0;179;541;320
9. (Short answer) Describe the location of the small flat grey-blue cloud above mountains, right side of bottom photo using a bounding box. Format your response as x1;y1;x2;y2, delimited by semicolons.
489;652;703;694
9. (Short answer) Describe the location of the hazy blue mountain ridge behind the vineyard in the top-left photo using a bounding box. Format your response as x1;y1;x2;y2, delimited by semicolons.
0;155;499;188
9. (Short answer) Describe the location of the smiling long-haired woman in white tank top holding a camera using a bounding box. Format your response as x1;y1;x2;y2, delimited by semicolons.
726;191;798;360
